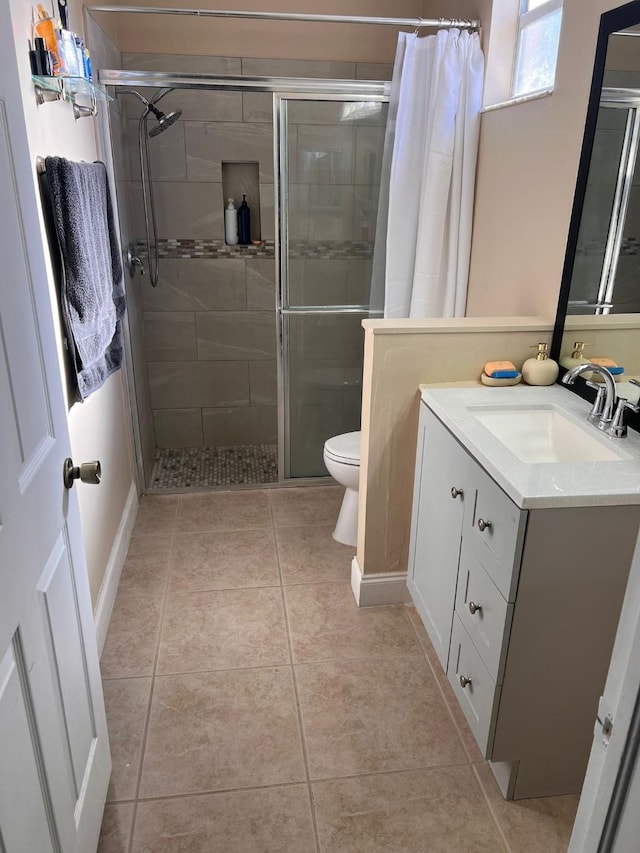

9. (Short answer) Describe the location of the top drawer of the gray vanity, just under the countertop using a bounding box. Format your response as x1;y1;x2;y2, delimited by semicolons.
463;465;527;601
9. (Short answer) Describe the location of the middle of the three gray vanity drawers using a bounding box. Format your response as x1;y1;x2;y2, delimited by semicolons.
456;542;513;684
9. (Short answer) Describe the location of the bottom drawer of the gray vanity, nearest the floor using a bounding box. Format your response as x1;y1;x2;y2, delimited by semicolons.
447;613;500;758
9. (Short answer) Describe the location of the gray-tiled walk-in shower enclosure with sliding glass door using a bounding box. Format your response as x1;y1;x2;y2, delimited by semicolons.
100;66;388;490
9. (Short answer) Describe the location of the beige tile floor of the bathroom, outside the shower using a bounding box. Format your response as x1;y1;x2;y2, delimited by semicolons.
99;486;577;853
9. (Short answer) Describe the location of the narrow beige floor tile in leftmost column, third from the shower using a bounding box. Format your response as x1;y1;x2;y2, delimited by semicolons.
100;593;162;678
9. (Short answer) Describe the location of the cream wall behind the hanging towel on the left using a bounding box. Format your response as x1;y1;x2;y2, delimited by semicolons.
13;0;133;605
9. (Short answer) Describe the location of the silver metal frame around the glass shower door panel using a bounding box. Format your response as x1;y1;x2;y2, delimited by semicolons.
273;91;389;483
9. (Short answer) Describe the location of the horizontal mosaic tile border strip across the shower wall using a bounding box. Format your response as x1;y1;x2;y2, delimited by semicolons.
136;239;373;261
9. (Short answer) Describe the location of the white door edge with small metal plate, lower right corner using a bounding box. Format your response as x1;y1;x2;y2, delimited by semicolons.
569;528;640;853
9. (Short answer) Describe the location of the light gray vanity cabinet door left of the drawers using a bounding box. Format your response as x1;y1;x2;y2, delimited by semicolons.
408;405;473;671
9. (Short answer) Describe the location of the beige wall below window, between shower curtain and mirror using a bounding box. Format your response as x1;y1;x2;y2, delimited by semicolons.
467;0;620;319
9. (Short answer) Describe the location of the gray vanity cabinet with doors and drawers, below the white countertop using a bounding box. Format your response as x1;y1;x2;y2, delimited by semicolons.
408;403;640;799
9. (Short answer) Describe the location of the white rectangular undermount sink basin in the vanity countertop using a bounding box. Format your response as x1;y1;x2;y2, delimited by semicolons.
471;406;621;464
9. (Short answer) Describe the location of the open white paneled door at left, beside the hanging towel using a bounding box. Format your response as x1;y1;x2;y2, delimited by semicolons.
0;81;110;853
